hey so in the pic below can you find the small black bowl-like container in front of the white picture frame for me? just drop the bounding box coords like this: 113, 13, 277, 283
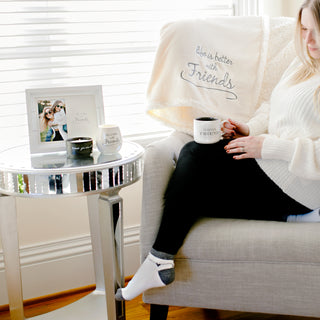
66, 137, 93, 159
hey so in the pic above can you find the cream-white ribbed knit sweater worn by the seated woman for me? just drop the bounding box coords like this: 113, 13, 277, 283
248, 59, 320, 209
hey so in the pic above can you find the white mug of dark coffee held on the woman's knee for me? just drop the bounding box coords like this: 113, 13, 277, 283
193, 117, 223, 144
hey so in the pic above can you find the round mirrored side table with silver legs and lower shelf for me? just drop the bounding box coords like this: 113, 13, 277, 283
0, 141, 144, 320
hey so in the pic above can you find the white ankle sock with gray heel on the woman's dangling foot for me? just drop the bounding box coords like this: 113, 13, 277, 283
116, 253, 174, 300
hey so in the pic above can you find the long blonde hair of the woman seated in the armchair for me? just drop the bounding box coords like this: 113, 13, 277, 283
292, 0, 320, 111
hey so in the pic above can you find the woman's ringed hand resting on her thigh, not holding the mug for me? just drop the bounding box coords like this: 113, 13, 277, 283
225, 136, 264, 160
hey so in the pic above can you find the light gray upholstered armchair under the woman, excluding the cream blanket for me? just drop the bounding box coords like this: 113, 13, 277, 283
141, 132, 320, 319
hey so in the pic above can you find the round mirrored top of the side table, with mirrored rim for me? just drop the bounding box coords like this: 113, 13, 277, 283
0, 141, 144, 197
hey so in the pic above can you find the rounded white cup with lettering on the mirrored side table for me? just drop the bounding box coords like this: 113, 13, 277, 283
97, 124, 122, 154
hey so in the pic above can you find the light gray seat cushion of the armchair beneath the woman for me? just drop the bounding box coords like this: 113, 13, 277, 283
177, 218, 320, 264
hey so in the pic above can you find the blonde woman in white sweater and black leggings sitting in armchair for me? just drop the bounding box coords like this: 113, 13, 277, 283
116, 0, 320, 300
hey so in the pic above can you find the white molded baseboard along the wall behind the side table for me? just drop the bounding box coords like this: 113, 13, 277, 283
0, 226, 140, 305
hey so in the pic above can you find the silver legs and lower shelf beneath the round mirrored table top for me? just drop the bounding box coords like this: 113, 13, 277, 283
0, 189, 125, 320
